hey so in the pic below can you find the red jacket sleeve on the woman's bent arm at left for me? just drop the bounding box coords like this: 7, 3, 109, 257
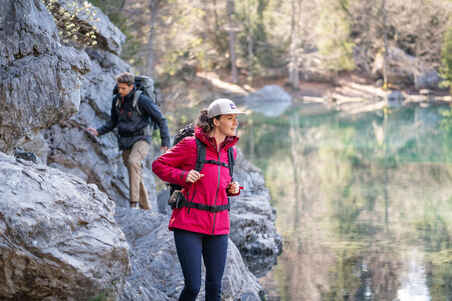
152, 139, 196, 185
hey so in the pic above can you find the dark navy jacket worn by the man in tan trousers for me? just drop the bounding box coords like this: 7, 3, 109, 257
97, 88, 170, 150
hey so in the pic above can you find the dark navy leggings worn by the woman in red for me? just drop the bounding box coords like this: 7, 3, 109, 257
174, 229, 228, 301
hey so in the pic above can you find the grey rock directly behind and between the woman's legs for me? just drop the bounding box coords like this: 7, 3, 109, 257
116, 208, 263, 301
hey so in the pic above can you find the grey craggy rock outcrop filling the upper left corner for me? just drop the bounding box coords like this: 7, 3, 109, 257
0, 0, 90, 151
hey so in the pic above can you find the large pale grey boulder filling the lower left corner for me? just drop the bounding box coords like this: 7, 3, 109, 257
0, 153, 129, 301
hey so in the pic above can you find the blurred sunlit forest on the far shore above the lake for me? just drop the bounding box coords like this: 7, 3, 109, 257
84, 0, 452, 89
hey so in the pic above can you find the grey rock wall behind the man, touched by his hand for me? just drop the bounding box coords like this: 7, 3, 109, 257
43, 49, 141, 206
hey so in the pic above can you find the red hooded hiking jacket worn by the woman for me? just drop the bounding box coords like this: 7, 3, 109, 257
152, 128, 239, 235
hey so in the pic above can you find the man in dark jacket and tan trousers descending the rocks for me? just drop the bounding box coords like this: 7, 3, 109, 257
86, 72, 170, 210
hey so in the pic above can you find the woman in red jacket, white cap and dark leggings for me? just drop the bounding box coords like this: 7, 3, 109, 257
152, 98, 243, 301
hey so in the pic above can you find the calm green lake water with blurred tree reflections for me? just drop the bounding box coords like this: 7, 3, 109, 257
241, 105, 452, 301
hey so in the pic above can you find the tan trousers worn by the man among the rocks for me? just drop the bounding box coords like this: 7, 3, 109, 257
122, 140, 151, 210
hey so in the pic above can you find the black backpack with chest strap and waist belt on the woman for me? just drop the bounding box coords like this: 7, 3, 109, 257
168, 123, 235, 212
